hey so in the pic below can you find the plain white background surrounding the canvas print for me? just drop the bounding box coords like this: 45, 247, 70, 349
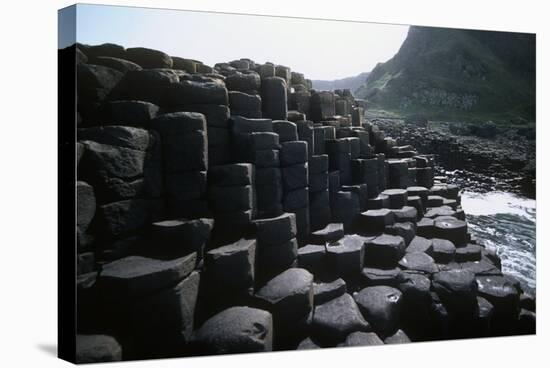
0, 0, 550, 368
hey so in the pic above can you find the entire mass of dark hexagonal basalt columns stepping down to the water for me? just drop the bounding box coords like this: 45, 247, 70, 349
69, 44, 536, 362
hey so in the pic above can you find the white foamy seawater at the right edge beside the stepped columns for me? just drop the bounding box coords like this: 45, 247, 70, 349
462, 191, 536, 293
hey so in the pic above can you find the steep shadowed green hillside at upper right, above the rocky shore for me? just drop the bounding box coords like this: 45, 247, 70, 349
356, 26, 535, 123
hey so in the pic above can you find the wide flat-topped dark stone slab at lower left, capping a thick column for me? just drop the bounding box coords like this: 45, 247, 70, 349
98, 253, 197, 298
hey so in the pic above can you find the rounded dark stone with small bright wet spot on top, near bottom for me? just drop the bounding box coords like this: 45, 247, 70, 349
353, 286, 402, 336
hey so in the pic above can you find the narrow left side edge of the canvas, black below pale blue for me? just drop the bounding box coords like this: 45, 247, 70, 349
57, 6, 76, 363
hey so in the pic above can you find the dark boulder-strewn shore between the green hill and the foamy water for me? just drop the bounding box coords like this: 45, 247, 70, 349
372, 118, 536, 198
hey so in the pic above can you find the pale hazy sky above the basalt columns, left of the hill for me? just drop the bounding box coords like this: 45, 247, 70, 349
69, 5, 409, 79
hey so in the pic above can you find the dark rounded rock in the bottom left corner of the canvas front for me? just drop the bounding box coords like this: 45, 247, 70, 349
75, 335, 122, 364
